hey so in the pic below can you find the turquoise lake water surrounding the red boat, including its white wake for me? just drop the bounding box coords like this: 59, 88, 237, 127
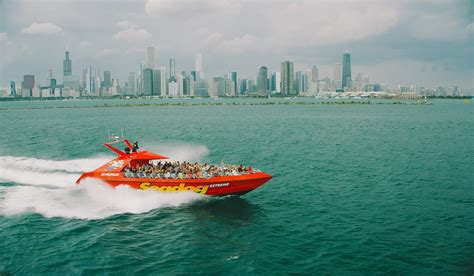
0, 99, 474, 275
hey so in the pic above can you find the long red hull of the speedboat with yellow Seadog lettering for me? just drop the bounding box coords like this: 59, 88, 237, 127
77, 172, 272, 196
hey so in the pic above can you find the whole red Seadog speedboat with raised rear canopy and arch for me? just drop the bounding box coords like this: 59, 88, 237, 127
76, 139, 272, 196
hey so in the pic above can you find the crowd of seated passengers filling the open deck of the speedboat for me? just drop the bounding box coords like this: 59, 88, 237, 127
124, 161, 255, 179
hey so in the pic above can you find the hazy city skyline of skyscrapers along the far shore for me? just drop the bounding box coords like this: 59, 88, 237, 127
0, 46, 472, 98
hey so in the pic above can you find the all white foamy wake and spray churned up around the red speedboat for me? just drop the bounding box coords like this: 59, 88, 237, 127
0, 145, 207, 219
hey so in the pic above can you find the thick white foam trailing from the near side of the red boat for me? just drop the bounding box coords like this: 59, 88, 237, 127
0, 180, 203, 219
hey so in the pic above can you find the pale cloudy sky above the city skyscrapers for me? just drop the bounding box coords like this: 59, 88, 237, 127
0, 0, 474, 88
